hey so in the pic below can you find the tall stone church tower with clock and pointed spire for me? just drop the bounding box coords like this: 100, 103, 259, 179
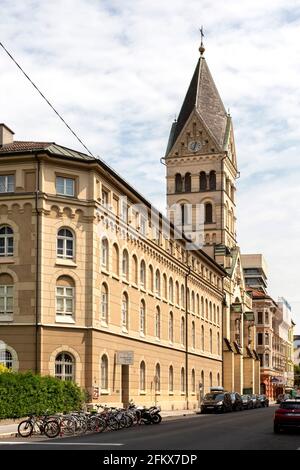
165, 39, 238, 268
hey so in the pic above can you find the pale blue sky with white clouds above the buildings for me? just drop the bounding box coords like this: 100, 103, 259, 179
0, 0, 300, 333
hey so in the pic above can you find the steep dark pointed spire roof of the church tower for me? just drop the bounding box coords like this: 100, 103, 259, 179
167, 57, 228, 153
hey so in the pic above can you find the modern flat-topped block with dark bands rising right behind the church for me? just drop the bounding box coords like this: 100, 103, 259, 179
242, 254, 268, 294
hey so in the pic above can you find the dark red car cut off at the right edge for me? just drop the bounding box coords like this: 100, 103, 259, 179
274, 398, 300, 434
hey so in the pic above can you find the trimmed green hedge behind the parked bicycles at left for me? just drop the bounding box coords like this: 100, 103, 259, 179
0, 372, 84, 419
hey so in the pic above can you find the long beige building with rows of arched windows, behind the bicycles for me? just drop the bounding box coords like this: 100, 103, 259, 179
0, 120, 226, 409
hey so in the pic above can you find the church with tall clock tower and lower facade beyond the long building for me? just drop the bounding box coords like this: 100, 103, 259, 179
165, 47, 260, 393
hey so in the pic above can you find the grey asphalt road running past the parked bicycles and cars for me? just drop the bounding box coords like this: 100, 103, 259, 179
0, 407, 300, 452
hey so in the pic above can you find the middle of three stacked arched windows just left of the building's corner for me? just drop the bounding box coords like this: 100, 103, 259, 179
56, 276, 75, 316
